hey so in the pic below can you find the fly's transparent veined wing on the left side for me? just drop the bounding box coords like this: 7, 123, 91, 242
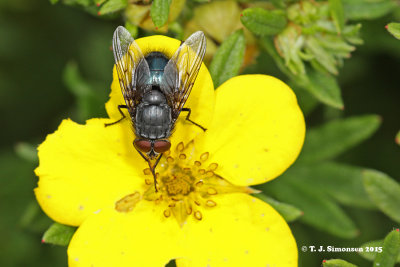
113, 26, 151, 114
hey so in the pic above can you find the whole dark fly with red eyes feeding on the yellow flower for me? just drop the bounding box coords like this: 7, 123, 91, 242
105, 26, 206, 192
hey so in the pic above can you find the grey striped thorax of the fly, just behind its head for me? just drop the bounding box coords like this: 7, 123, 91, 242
135, 103, 172, 139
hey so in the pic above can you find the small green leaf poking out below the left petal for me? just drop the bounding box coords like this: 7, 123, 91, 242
42, 223, 76, 246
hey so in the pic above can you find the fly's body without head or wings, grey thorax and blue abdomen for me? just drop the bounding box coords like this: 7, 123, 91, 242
135, 52, 173, 140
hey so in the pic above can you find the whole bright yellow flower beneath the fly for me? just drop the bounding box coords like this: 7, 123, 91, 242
35, 36, 305, 267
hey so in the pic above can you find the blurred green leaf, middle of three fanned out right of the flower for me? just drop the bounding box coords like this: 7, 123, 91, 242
285, 162, 376, 209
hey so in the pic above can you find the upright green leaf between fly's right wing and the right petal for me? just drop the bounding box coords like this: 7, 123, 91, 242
209, 30, 246, 88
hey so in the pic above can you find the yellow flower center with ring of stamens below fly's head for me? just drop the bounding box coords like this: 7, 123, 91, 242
138, 141, 254, 226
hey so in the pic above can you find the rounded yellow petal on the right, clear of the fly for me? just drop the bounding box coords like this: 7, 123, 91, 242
197, 75, 305, 185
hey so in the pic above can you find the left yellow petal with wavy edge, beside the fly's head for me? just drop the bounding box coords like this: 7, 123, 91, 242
35, 119, 148, 225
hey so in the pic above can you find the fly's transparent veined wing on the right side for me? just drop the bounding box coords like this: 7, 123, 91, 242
160, 31, 206, 121
